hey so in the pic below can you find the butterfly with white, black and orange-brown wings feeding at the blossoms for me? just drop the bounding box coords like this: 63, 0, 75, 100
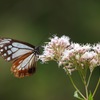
0, 38, 39, 78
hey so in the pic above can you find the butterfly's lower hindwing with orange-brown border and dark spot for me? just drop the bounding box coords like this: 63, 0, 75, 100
11, 53, 36, 78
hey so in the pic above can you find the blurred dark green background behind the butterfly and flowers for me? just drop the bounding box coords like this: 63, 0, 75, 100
0, 0, 100, 100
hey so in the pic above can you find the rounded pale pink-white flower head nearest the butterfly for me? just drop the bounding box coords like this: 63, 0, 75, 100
39, 36, 70, 62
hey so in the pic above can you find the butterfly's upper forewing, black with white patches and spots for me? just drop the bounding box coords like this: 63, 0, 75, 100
0, 38, 35, 61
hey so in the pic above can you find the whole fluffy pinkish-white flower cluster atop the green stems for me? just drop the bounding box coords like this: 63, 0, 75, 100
39, 36, 100, 73
